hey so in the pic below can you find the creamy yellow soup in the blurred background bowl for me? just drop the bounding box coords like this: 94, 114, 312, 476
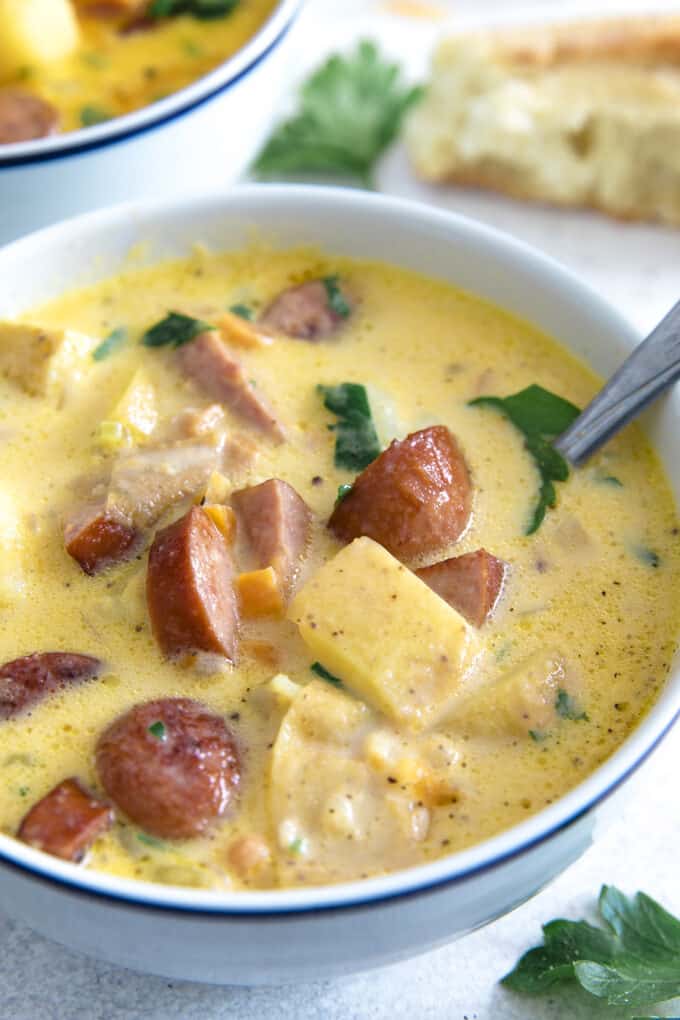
0, 0, 275, 132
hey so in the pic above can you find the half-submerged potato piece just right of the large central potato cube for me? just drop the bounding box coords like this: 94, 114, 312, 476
452, 651, 566, 736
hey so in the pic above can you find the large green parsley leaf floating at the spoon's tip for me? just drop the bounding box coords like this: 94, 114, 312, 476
470, 386, 581, 534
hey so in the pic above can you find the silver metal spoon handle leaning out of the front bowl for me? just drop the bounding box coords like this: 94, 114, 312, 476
553, 301, 680, 464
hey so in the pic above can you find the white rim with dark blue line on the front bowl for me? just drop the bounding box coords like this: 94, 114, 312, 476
0, 185, 680, 920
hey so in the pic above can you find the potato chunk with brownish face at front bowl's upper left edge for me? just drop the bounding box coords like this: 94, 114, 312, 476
0, 322, 97, 398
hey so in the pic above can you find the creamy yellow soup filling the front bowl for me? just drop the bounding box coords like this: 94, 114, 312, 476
0, 247, 680, 888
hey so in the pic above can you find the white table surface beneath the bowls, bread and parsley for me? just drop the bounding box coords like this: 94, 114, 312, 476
0, 0, 680, 1020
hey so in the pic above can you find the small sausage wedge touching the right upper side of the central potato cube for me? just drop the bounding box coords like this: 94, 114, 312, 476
416, 549, 508, 627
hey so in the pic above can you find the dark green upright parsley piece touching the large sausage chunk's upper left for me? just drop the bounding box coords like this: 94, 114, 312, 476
318, 383, 380, 471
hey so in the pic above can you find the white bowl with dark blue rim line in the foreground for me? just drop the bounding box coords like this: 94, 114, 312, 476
0, 187, 680, 984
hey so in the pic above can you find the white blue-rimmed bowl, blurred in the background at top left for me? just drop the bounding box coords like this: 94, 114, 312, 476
0, 0, 302, 244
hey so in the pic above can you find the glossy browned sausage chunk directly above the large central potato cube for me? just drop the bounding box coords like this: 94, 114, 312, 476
328, 425, 472, 562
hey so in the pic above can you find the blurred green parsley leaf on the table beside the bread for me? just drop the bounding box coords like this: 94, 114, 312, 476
253, 40, 422, 188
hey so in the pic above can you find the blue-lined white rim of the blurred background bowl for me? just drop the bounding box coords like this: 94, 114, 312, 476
0, 0, 304, 171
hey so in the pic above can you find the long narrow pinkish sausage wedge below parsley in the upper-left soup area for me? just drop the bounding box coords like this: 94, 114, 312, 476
178, 329, 283, 443
